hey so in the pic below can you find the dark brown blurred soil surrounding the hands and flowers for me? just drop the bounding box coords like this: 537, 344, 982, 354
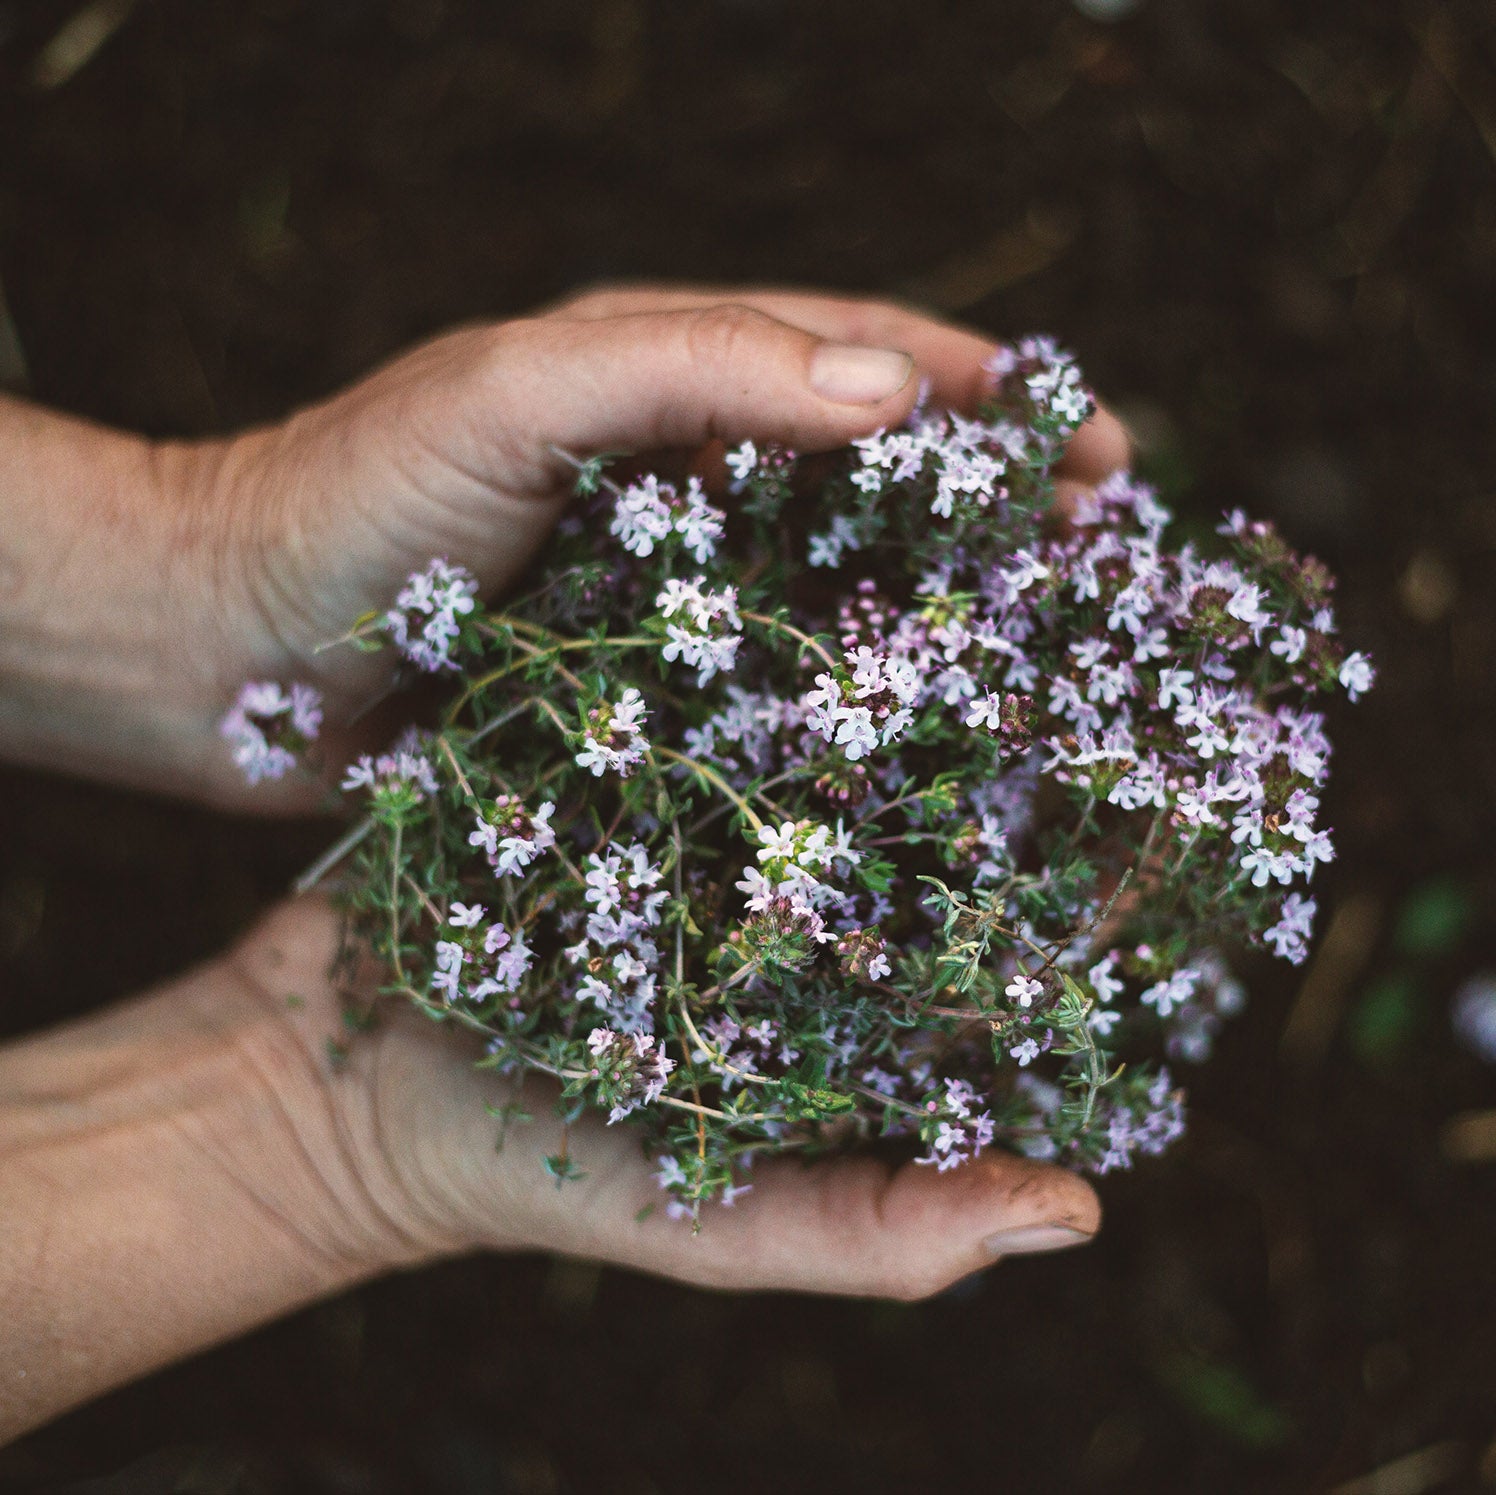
0, 0, 1496, 1495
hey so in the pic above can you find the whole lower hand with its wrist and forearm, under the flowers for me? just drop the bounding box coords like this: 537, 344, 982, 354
0, 898, 1100, 1444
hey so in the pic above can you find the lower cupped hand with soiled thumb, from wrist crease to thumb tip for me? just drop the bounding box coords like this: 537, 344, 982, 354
229, 898, 1101, 1299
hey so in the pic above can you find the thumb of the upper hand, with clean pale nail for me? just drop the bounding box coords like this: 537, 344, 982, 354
480, 304, 917, 481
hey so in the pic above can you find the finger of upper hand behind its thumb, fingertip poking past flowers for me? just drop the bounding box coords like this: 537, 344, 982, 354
548, 286, 1131, 483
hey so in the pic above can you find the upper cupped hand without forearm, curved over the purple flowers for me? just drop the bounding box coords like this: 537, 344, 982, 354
166, 287, 1128, 810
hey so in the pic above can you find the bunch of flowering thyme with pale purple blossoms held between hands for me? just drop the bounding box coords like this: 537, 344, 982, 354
227, 338, 1373, 1215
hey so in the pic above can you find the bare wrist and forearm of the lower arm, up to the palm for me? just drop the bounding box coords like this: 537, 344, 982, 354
0, 897, 459, 1441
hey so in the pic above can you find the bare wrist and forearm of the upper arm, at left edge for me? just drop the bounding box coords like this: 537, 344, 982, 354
0, 400, 237, 787
